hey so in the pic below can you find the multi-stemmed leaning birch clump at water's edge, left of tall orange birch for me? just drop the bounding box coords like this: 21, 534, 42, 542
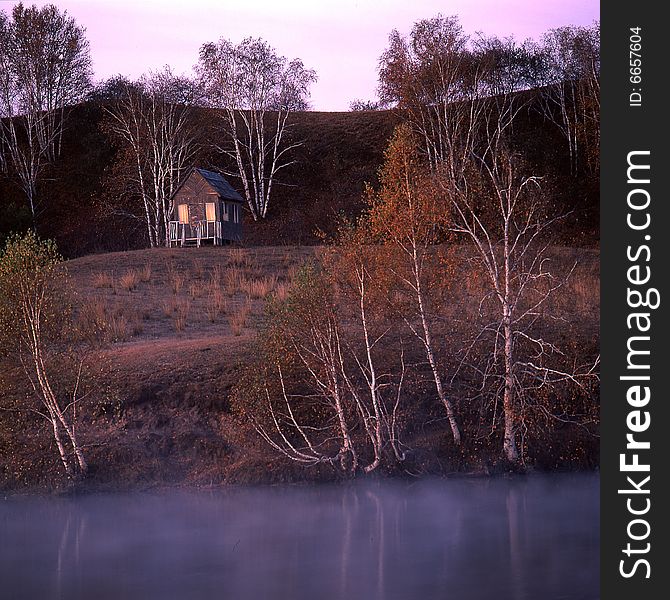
240, 266, 405, 475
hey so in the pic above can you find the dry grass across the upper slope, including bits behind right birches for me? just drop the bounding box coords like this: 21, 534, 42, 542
65, 247, 599, 376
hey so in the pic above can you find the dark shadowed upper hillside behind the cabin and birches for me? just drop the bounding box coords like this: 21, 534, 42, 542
0, 104, 599, 257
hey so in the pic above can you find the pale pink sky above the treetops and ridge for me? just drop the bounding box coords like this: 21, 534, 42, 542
0, 0, 600, 110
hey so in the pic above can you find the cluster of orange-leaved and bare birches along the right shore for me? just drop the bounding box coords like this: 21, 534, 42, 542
238, 116, 598, 475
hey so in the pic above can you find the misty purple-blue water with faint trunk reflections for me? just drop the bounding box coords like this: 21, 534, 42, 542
0, 474, 599, 600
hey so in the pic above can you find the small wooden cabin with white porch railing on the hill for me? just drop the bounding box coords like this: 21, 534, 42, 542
170, 168, 244, 246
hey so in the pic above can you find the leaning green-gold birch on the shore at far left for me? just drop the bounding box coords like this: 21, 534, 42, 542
0, 231, 88, 476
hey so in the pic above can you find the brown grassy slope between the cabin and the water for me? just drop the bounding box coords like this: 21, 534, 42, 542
0, 246, 599, 490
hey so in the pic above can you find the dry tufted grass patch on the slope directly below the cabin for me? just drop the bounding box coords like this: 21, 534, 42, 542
68, 247, 322, 352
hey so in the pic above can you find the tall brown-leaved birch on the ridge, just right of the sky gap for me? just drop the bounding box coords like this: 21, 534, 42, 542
379, 15, 545, 176
